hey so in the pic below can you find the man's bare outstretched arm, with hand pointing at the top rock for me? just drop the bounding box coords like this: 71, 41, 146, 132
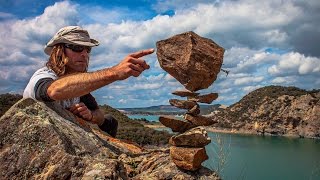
47, 49, 154, 100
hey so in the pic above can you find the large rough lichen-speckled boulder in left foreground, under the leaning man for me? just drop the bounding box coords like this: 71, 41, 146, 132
0, 99, 126, 179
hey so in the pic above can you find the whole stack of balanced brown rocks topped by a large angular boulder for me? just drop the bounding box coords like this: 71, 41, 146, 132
157, 32, 224, 171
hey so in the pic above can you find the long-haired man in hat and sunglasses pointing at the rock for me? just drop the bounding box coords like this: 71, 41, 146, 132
23, 26, 154, 137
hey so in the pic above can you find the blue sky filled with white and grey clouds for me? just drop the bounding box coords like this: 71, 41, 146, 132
0, 0, 320, 108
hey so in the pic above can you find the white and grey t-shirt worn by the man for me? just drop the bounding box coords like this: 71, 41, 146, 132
23, 67, 80, 108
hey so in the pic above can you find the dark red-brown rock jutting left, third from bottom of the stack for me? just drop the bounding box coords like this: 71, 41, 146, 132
159, 116, 195, 133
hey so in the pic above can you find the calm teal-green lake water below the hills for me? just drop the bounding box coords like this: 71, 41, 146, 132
127, 116, 320, 180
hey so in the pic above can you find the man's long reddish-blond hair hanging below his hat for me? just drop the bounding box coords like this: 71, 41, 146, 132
46, 44, 69, 77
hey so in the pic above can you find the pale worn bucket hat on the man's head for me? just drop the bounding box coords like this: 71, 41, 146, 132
44, 26, 99, 55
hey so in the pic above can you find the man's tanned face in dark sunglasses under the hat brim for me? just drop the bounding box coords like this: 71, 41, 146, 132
65, 44, 90, 74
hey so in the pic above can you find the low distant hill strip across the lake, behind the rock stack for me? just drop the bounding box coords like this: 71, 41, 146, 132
118, 104, 221, 115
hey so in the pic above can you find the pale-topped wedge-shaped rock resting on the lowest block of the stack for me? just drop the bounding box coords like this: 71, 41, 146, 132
169, 127, 211, 147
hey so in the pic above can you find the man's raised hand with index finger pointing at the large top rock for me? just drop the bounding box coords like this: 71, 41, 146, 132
111, 49, 154, 80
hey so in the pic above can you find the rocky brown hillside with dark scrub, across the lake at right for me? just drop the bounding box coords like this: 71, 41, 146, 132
213, 86, 320, 138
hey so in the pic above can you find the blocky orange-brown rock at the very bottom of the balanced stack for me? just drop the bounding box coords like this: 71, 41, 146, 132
170, 146, 208, 171
